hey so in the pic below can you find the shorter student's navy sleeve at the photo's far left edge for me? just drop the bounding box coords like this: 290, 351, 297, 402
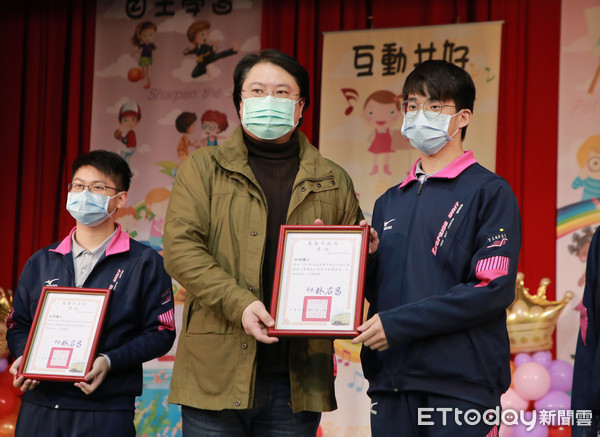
6, 260, 37, 358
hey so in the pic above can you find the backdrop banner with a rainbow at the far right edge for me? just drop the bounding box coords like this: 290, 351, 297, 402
556, 0, 600, 363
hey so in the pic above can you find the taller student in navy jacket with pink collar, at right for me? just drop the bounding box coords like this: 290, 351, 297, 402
353, 60, 521, 437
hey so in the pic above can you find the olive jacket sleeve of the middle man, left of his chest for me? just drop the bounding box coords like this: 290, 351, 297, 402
164, 150, 258, 324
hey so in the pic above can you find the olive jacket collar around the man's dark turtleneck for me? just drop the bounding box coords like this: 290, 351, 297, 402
214, 126, 333, 180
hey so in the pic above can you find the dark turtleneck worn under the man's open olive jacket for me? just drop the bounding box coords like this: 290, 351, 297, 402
244, 127, 300, 373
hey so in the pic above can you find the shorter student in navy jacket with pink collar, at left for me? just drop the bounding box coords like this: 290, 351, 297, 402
6, 150, 175, 437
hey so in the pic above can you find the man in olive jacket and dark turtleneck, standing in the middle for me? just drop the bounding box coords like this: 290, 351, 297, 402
164, 49, 376, 437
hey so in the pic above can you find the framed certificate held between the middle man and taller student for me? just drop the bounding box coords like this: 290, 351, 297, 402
268, 225, 369, 338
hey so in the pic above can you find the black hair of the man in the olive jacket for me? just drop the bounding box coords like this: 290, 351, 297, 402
233, 49, 310, 126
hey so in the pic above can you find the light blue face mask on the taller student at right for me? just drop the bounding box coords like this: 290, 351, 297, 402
401, 110, 461, 156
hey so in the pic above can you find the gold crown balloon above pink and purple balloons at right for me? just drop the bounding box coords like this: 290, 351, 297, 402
506, 272, 573, 354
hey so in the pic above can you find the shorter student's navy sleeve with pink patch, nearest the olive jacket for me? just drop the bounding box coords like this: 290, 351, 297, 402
105, 250, 175, 371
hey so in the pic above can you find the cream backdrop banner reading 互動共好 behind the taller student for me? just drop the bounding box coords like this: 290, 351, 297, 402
319, 22, 502, 436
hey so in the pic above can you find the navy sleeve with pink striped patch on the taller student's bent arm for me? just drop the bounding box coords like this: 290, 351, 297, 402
379, 181, 521, 346
